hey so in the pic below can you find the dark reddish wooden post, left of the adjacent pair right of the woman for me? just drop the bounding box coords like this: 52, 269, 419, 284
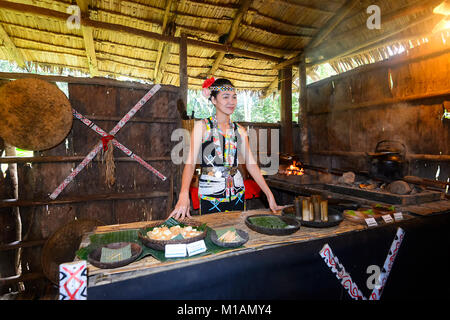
279, 66, 294, 153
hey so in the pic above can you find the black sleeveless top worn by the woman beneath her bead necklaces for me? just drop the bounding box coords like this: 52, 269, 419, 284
201, 118, 241, 167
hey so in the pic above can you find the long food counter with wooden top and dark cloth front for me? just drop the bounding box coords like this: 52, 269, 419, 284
77, 205, 450, 300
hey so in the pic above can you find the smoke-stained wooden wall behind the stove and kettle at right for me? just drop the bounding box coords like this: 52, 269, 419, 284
294, 39, 450, 181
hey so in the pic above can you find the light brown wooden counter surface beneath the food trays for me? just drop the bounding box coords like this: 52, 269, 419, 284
80, 210, 413, 287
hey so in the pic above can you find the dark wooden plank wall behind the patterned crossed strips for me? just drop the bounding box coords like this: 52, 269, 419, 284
6, 84, 180, 292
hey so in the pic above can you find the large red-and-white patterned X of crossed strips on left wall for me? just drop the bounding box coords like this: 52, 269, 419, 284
50, 84, 166, 200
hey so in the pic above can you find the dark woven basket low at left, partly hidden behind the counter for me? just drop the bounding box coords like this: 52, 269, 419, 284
41, 220, 104, 284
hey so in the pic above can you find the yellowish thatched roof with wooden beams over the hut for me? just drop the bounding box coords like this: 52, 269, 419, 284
0, 0, 442, 93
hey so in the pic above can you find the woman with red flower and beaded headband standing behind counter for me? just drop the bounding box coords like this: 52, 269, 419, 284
169, 78, 283, 219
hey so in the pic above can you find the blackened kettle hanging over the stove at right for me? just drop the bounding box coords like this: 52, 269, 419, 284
367, 140, 406, 181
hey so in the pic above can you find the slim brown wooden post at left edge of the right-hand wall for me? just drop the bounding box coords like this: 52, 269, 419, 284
298, 54, 309, 163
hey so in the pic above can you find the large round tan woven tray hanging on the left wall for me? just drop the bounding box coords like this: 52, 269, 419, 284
0, 78, 73, 151
